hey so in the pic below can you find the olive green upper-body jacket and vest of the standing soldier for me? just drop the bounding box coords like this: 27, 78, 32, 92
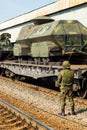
58, 69, 74, 86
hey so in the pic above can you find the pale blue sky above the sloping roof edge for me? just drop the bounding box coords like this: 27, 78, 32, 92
0, 0, 58, 23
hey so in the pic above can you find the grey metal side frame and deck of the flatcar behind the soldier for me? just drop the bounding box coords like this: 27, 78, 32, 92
0, 61, 87, 79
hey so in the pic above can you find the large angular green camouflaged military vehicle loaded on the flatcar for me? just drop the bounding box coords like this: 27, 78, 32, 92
13, 17, 87, 62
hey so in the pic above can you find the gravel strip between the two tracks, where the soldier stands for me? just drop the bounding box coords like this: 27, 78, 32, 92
0, 75, 87, 130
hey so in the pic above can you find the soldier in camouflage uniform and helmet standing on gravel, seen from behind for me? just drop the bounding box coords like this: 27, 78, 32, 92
56, 61, 75, 116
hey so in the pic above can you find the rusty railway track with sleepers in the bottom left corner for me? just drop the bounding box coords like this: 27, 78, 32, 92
0, 98, 53, 130
